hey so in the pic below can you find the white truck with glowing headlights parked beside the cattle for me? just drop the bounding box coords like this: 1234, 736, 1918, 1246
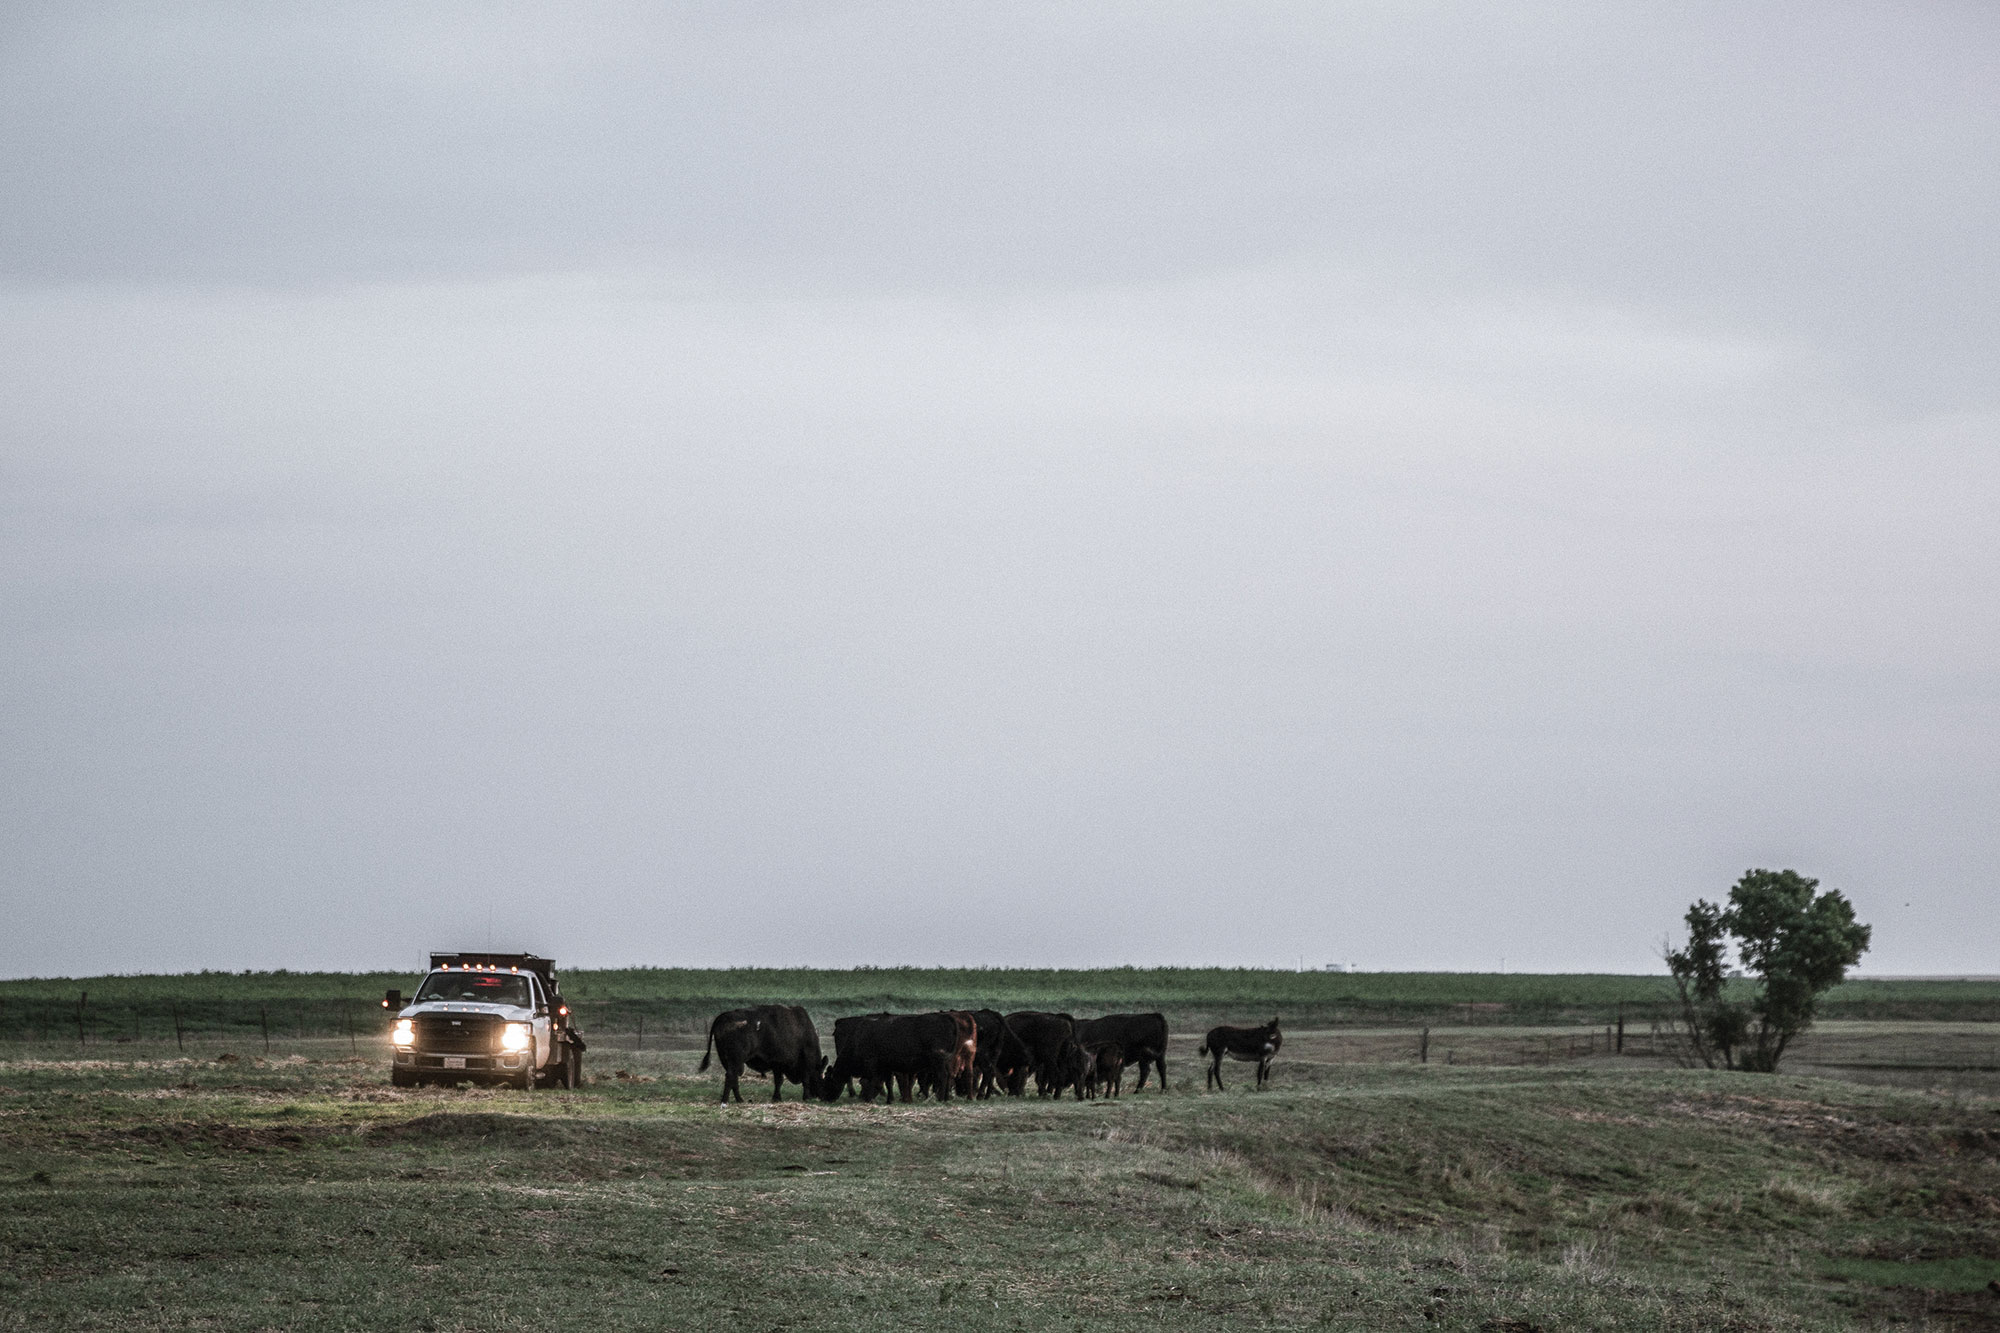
382, 953, 584, 1089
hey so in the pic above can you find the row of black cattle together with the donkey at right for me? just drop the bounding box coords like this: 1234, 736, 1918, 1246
700, 1005, 1284, 1103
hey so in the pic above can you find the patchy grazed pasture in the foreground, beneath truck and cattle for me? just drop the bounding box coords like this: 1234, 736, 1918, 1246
0, 1025, 2000, 1333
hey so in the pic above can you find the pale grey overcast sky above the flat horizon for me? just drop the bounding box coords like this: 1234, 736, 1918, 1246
0, 0, 2000, 975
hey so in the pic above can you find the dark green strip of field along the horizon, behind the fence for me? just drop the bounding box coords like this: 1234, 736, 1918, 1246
11, 967, 2000, 1045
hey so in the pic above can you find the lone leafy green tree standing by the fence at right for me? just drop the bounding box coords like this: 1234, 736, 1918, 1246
1666, 871, 1870, 1073
